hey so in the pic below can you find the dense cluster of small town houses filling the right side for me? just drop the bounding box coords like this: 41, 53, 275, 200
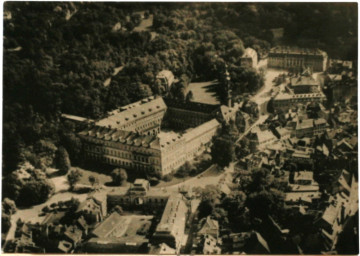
235, 50, 358, 254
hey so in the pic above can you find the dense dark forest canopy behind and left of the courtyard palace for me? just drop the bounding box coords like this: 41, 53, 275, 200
2, 2, 357, 210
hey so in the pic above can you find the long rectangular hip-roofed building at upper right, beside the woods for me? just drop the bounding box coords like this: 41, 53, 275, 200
268, 46, 328, 72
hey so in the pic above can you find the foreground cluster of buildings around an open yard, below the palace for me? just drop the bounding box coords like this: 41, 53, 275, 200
7, 178, 264, 254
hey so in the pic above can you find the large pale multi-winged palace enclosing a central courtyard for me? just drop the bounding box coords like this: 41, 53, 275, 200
78, 97, 220, 175
